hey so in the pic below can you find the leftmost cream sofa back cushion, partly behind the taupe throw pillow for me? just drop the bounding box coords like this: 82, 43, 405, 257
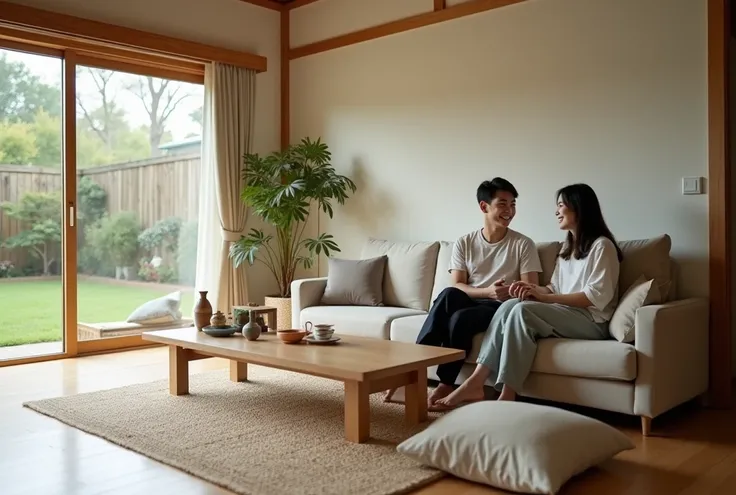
361, 239, 439, 311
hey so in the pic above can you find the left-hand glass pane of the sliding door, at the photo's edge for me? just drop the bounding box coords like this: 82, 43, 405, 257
0, 48, 63, 360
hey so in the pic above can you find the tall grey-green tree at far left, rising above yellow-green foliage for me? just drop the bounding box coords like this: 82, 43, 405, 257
0, 52, 61, 123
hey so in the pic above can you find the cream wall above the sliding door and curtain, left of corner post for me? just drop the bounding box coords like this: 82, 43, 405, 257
5, 0, 280, 301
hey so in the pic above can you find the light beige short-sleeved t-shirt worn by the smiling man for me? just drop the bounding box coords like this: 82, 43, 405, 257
450, 229, 542, 288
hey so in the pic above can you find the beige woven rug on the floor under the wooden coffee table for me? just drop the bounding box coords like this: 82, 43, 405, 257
24, 366, 443, 495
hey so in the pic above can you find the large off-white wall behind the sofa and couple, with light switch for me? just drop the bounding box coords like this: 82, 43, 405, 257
291, 0, 708, 296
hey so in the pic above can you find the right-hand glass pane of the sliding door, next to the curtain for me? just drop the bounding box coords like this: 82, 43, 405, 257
77, 66, 204, 341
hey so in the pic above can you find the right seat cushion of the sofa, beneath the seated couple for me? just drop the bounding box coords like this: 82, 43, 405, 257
390, 315, 636, 381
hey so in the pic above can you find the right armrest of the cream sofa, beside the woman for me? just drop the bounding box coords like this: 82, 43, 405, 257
634, 298, 709, 418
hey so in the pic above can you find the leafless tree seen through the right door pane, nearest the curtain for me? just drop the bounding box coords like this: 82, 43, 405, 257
128, 76, 190, 156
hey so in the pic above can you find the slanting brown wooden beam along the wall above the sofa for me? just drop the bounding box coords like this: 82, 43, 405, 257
289, 0, 526, 60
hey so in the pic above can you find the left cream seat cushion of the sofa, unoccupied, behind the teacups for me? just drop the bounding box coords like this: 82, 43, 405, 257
299, 306, 425, 339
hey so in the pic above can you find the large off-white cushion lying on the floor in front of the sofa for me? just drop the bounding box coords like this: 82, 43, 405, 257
397, 401, 634, 494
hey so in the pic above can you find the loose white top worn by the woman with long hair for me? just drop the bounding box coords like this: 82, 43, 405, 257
548, 237, 620, 323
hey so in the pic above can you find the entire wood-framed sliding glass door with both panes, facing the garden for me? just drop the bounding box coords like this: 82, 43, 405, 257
0, 39, 204, 366
